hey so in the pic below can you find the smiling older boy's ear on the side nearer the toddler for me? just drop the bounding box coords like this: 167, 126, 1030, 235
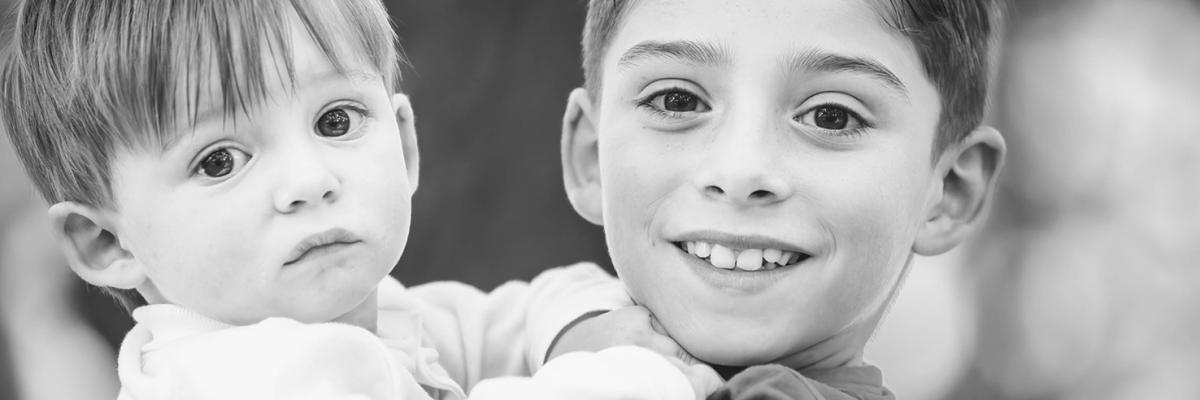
563, 88, 604, 225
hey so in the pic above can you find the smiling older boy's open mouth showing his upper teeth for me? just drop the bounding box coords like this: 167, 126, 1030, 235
671, 241, 811, 271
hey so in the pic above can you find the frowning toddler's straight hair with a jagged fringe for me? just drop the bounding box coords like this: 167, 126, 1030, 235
0, 0, 402, 310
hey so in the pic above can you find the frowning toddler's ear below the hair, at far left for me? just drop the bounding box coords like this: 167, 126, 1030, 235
47, 202, 146, 289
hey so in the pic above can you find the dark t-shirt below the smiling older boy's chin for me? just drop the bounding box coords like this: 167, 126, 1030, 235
708, 364, 895, 400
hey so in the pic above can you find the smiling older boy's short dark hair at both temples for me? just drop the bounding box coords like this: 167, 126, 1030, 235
583, 0, 1003, 155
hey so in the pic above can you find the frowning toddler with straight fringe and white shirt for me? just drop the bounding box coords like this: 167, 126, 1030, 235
2, 0, 673, 399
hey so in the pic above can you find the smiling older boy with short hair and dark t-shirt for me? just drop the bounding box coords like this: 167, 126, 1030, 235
563, 0, 1004, 399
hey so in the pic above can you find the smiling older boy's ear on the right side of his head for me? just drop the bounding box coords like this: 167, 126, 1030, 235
912, 126, 1007, 256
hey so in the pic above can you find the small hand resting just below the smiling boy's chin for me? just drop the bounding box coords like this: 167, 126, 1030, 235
546, 305, 696, 360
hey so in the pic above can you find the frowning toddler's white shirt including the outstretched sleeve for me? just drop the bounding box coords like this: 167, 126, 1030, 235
118, 263, 630, 400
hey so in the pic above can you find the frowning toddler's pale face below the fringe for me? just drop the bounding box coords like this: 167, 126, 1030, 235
113, 23, 415, 323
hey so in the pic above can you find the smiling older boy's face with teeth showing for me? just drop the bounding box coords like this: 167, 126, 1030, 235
577, 0, 941, 365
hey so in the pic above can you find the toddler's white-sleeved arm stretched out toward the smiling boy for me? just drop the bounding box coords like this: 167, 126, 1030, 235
398, 263, 631, 389
